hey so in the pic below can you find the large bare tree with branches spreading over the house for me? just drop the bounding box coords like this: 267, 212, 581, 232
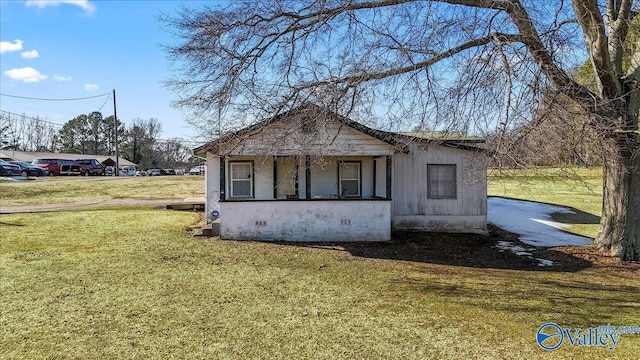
161, 0, 640, 260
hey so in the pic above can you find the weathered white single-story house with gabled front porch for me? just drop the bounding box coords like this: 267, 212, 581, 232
194, 105, 487, 242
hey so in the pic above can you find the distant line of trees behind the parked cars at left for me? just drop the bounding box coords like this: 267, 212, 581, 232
0, 111, 198, 169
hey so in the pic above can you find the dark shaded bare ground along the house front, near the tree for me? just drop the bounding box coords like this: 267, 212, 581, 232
260, 225, 592, 272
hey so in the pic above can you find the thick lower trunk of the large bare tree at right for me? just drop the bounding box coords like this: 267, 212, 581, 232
594, 132, 640, 261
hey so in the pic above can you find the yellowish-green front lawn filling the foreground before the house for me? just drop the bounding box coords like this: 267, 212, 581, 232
0, 171, 640, 359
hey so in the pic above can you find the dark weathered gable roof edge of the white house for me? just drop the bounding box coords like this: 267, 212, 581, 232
193, 103, 484, 157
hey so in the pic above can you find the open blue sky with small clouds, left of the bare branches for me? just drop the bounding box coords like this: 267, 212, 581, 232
0, 0, 210, 140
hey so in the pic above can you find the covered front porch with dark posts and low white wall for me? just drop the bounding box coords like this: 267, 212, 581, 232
206, 153, 392, 241
